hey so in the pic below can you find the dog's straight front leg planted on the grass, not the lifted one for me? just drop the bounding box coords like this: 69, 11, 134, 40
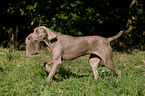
47, 57, 61, 82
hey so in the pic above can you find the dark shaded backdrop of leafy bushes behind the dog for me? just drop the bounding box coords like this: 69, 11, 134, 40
0, 0, 145, 50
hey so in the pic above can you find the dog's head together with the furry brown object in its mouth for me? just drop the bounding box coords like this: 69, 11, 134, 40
25, 26, 56, 57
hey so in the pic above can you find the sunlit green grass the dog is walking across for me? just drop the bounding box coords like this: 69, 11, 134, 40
0, 48, 145, 96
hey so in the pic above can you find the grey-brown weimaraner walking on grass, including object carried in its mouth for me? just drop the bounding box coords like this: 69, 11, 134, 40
26, 26, 123, 81
